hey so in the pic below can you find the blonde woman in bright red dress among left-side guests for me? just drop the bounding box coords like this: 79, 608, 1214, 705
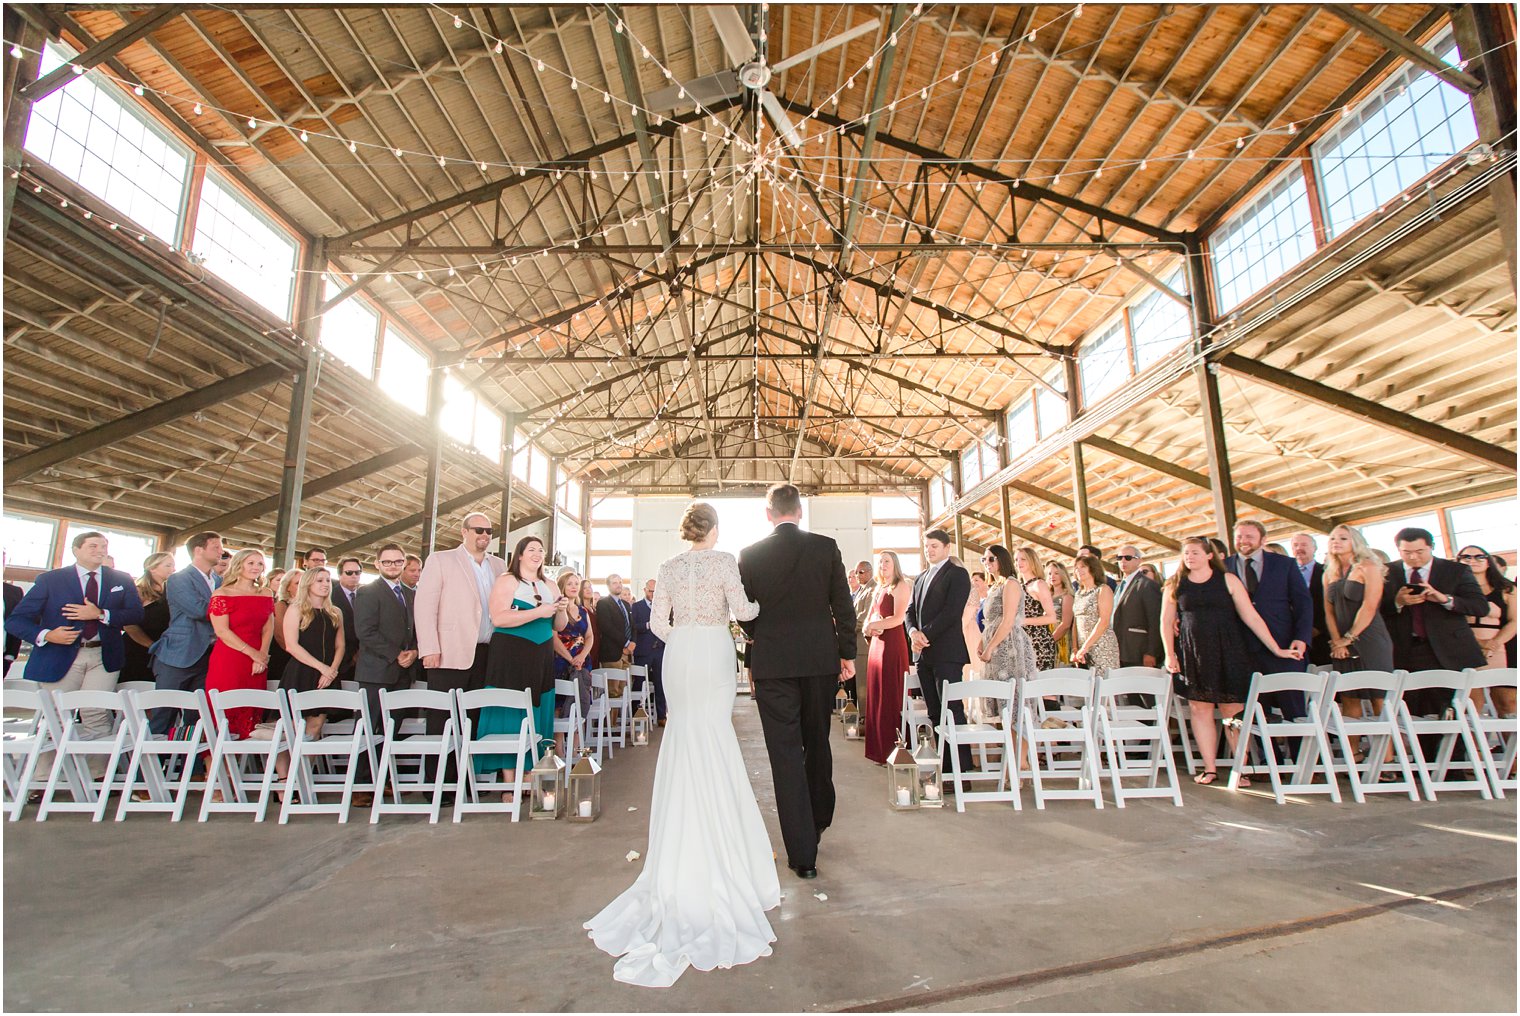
205, 551, 275, 739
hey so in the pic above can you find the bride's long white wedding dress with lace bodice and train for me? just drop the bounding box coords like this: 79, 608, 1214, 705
585, 551, 781, 987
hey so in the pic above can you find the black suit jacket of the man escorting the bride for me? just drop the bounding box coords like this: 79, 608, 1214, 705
739, 522, 856, 680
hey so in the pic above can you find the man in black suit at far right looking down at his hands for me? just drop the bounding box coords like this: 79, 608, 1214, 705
1383, 526, 1488, 716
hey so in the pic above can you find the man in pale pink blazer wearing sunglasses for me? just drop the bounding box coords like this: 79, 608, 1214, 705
415, 511, 506, 757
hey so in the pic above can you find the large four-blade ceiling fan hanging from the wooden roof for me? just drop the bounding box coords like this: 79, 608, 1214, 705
644, 5, 882, 148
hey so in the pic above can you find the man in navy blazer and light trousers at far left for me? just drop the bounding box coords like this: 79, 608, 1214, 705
5, 532, 143, 738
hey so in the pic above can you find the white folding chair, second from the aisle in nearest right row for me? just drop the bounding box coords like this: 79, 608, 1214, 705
1018, 666, 1104, 809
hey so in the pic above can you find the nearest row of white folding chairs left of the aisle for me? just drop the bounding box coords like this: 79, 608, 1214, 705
3, 681, 581, 823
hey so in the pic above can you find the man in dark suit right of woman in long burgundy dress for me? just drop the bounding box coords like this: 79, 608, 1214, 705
906, 529, 973, 773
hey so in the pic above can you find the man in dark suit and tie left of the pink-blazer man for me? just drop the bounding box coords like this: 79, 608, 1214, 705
348, 543, 416, 805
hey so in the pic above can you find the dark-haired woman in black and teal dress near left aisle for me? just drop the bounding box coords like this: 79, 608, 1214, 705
474, 537, 570, 802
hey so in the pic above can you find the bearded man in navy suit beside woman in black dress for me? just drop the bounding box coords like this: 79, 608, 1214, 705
1225, 519, 1315, 719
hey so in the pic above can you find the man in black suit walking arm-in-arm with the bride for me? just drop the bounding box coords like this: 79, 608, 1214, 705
739, 484, 856, 879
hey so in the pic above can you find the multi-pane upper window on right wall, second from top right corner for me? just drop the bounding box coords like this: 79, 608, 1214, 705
1208, 166, 1315, 310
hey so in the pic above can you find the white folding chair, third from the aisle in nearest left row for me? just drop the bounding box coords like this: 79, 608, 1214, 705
280, 684, 375, 826
